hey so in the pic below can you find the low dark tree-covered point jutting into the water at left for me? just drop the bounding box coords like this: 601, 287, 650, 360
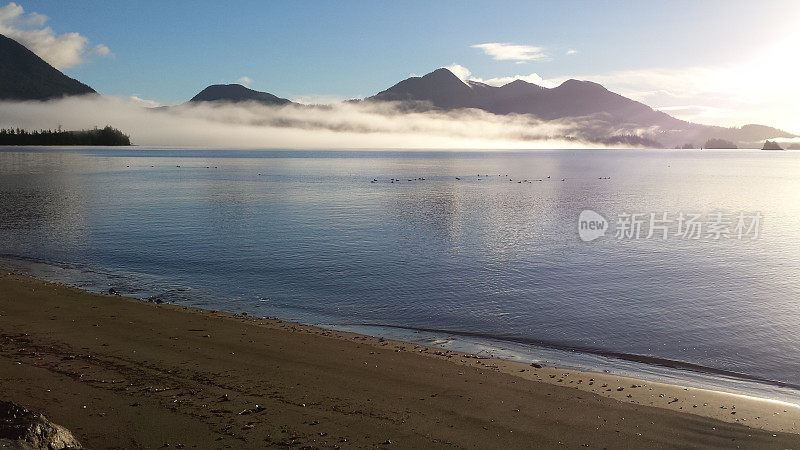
0, 126, 131, 146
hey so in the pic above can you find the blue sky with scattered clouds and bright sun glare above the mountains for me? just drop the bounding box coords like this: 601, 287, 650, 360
0, 0, 800, 133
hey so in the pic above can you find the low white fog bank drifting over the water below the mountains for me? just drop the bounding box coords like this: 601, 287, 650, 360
0, 96, 668, 149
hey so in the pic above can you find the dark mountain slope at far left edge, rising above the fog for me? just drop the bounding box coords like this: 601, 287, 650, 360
0, 34, 97, 100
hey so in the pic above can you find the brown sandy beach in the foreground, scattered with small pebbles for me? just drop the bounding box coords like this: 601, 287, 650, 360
0, 272, 800, 449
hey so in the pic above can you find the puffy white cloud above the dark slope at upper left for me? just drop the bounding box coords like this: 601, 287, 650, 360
0, 2, 111, 69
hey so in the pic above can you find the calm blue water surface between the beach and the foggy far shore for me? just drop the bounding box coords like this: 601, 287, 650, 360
0, 147, 800, 399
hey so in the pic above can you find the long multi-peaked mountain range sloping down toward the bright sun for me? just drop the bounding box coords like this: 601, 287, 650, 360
366, 68, 795, 148
